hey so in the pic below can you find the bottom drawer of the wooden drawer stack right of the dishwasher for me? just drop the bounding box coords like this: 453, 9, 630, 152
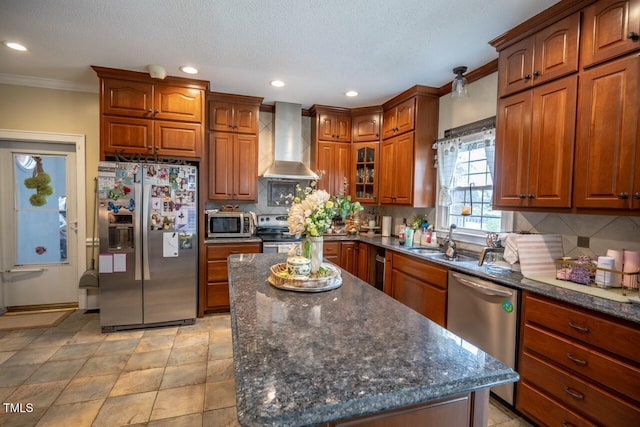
516, 381, 596, 427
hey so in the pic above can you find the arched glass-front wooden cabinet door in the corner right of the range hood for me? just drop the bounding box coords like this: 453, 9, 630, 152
351, 142, 380, 203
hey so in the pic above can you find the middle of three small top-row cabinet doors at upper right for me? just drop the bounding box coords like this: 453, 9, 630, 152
532, 12, 580, 85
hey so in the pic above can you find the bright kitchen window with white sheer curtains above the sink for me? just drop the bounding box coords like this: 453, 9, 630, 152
436, 130, 511, 241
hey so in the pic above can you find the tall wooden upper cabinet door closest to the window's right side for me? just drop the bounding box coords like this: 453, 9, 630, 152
493, 91, 532, 207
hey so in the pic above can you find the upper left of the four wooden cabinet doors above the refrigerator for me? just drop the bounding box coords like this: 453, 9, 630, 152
102, 79, 153, 117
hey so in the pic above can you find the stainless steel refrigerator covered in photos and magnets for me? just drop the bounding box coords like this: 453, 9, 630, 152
98, 162, 198, 332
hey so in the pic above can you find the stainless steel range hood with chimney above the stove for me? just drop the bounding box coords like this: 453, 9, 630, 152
262, 102, 318, 180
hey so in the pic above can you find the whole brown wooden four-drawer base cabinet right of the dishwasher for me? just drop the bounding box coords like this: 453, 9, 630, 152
516, 291, 640, 426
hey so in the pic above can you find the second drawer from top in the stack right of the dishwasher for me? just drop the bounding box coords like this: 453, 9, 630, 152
524, 325, 640, 402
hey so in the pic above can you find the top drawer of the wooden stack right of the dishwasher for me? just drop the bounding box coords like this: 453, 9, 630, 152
524, 292, 640, 363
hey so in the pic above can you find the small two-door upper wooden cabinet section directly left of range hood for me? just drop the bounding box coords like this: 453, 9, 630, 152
207, 93, 262, 134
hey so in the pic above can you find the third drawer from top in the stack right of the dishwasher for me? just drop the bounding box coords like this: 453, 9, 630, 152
519, 349, 640, 426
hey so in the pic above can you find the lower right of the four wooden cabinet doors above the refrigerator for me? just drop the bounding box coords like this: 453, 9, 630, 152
154, 120, 203, 159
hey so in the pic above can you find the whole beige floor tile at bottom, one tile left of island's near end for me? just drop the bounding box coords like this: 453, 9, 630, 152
150, 384, 204, 420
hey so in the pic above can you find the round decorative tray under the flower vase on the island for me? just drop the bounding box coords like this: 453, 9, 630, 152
267, 262, 342, 292
